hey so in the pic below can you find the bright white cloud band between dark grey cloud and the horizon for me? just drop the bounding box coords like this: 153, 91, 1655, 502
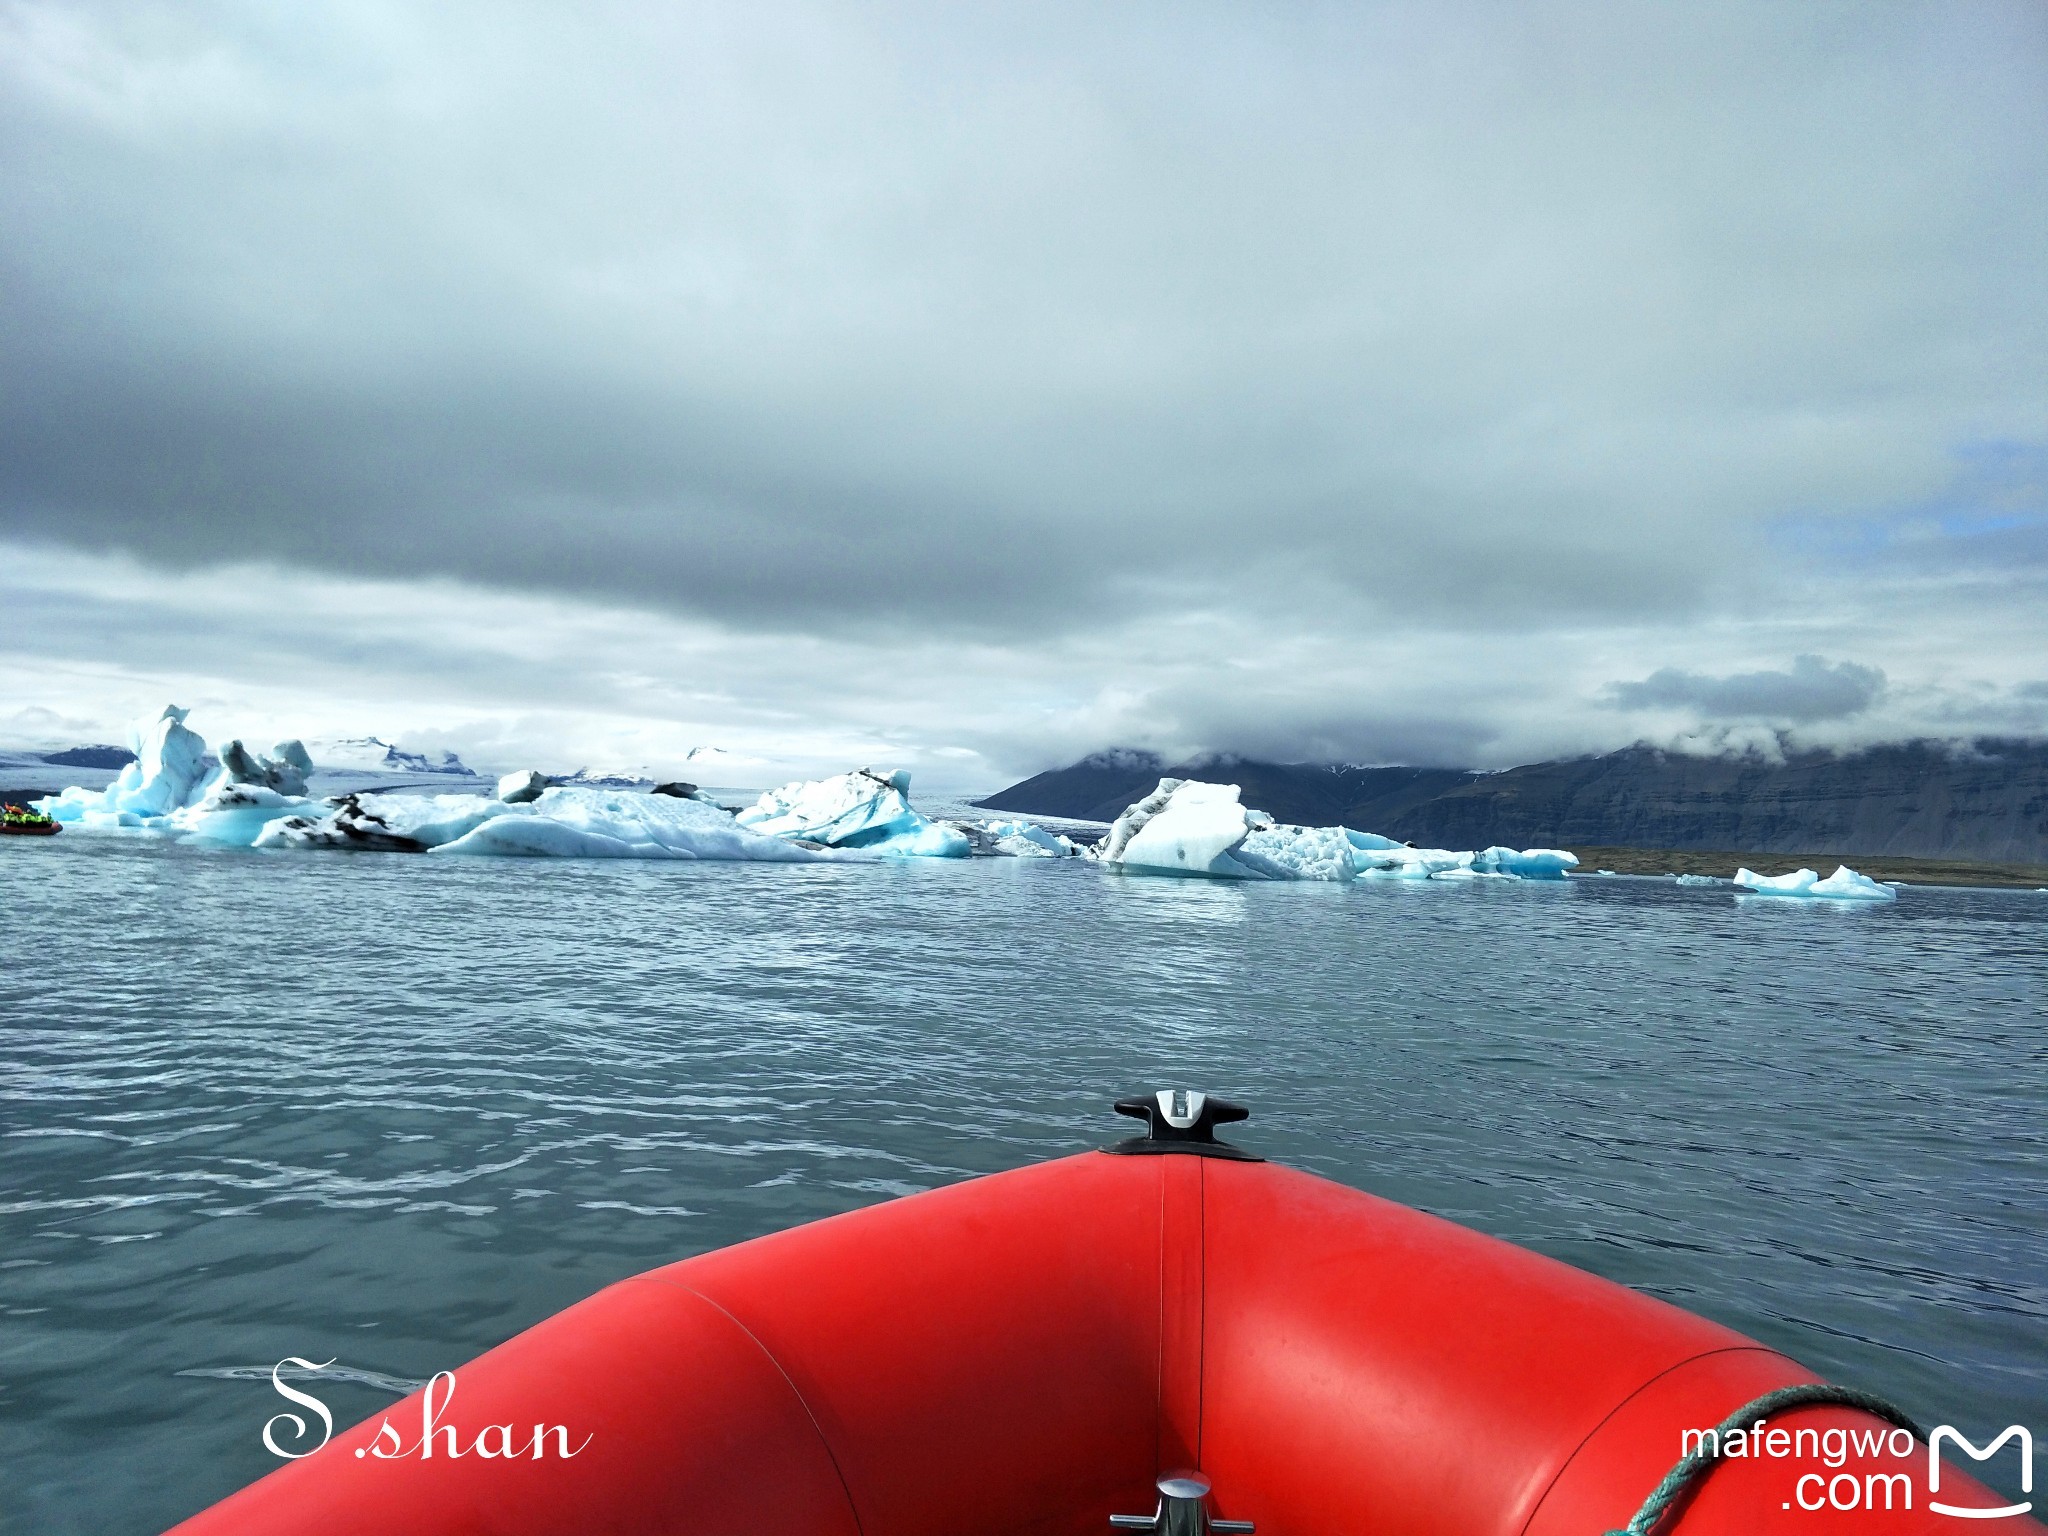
0, 545, 2048, 791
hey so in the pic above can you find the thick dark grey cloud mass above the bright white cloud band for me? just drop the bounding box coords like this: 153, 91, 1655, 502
0, 4, 2048, 638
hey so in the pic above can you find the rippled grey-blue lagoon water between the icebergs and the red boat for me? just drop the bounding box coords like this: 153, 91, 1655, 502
0, 836, 2048, 1532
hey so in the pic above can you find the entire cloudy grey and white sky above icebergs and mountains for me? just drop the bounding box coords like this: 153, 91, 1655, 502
0, 0, 2048, 786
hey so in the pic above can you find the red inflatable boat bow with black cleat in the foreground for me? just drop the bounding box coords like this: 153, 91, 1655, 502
178, 1094, 2042, 1536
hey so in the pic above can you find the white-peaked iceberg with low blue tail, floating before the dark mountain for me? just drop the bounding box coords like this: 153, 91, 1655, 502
1094, 778, 1579, 881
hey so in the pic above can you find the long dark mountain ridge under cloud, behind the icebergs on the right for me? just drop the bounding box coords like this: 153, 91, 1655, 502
979, 739, 2048, 864
